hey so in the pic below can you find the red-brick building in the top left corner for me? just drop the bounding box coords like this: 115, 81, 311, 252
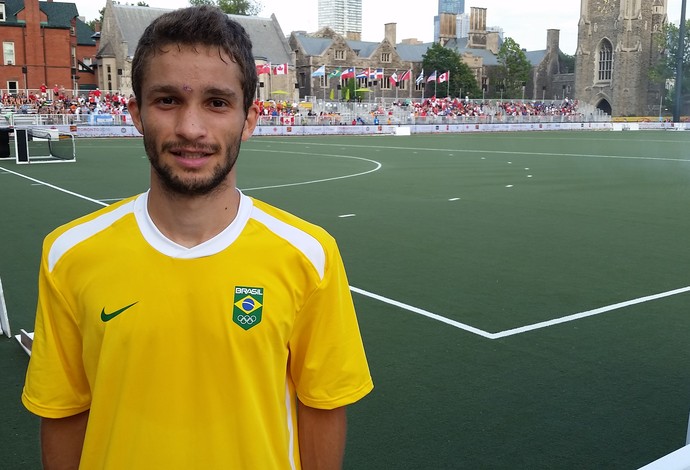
0, 0, 97, 94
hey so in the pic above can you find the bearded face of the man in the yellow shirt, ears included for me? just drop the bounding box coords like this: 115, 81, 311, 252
129, 45, 258, 196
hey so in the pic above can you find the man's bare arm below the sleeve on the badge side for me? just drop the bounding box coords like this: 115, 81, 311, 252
297, 401, 347, 470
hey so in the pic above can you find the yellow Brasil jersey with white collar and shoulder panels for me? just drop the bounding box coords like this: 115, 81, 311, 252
22, 189, 373, 470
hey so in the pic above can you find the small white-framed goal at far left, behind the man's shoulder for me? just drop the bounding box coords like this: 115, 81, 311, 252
14, 127, 77, 163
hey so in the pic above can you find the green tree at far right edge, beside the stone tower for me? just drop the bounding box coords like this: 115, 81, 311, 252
649, 20, 690, 115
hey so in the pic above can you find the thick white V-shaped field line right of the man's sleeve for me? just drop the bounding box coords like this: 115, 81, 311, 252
350, 286, 690, 340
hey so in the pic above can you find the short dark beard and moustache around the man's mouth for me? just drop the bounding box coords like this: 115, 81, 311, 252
144, 135, 242, 196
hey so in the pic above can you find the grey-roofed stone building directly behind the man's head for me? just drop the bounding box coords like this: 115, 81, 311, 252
98, 0, 297, 100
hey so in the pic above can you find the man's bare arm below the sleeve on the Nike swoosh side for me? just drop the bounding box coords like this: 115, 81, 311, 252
41, 411, 89, 470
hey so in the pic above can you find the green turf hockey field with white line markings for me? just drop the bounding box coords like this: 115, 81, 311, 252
0, 132, 690, 469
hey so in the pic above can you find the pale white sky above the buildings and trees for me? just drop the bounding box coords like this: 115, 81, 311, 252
73, 0, 690, 54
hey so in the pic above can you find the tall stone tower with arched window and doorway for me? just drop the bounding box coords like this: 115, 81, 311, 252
575, 0, 668, 116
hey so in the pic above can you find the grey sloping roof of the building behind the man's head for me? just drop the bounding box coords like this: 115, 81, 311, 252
105, 3, 291, 64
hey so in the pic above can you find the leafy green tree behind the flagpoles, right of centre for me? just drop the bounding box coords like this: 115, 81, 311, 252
422, 43, 481, 98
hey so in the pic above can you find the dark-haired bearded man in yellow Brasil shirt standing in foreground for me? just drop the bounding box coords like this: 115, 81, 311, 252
22, 7, 373, 470
